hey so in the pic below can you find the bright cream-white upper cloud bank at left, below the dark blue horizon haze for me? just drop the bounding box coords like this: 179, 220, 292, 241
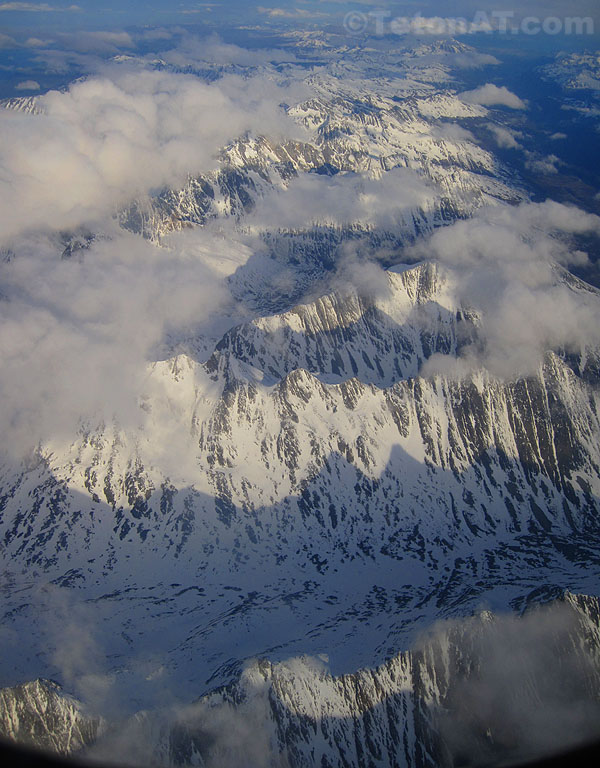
0, 69, 298, 243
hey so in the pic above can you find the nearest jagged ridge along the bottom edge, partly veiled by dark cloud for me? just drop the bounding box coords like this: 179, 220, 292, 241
0, 594, 600, 768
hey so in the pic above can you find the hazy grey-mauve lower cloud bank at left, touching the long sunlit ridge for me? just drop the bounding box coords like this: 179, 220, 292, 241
0, 226, 244, 456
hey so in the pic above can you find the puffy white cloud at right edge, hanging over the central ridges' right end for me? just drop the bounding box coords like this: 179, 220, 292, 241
416, 202, 600, 378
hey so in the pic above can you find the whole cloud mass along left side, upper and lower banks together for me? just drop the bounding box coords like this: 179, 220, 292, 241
0, 68, 298, 454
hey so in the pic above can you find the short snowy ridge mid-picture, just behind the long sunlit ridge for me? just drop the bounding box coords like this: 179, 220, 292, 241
207, 263, 472, 388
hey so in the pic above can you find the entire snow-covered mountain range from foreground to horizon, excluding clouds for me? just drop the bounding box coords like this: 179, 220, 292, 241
0, 31, 600, 766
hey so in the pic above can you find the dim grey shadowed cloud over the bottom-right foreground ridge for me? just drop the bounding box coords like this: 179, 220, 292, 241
420, 603, 600, 765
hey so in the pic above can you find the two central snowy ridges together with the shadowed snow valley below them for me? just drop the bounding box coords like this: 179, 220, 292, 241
2, 264, 600, 704
